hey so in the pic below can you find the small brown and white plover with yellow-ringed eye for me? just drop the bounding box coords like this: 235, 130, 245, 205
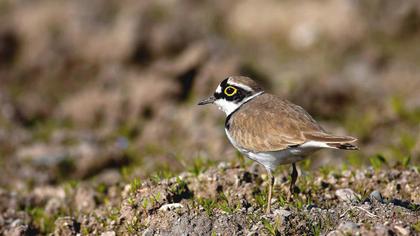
198, 76, 358, 214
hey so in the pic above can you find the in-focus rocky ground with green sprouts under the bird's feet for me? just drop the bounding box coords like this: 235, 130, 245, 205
0, 162, 420, 235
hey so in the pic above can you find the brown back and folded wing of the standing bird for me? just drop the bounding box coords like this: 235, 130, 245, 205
228, 93, 344, 152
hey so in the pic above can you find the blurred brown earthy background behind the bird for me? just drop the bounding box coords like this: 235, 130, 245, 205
0, 0, 420, 190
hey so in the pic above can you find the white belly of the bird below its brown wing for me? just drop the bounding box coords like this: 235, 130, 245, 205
225, 129, 322, 171
